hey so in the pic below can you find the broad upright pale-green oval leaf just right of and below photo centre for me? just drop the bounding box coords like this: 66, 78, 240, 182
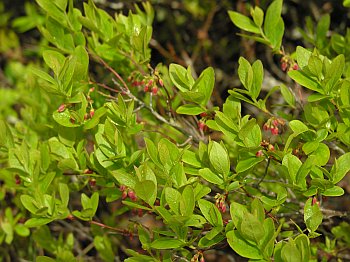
209, 141, 230, 175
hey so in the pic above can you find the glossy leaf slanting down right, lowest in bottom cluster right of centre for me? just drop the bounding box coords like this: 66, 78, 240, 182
226, 230, 263, 259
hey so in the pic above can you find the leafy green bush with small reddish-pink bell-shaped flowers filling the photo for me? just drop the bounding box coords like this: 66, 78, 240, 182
0, 0, 350, 261
